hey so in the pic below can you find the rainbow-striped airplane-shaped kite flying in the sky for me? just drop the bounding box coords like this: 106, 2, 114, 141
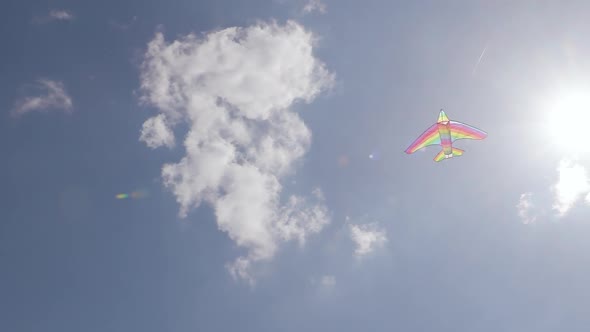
406, 109, 488, 161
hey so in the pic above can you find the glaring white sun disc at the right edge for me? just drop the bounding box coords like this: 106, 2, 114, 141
546, 90, 590, 154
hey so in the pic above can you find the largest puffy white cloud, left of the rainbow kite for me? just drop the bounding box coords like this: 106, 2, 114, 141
141, 22, 333, 282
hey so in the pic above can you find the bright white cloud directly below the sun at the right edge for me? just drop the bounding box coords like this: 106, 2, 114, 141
553, 160, 590, 216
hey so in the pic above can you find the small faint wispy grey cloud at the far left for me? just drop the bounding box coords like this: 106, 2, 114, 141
12, 79, 73, 116
